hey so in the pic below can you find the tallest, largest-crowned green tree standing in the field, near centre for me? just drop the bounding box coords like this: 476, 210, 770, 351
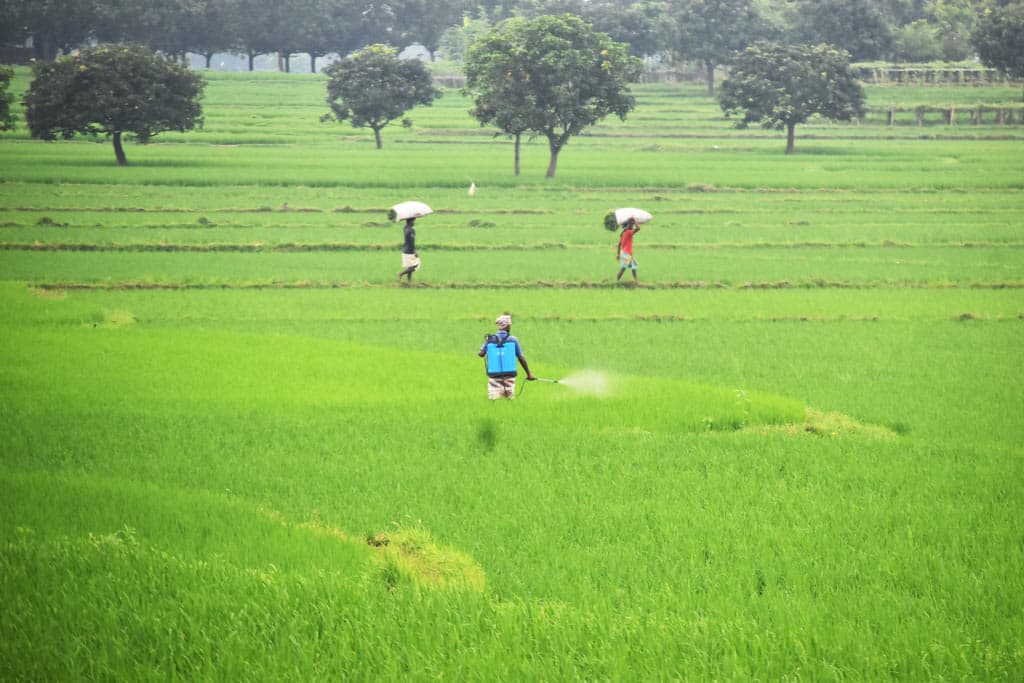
466, 14, 642, 178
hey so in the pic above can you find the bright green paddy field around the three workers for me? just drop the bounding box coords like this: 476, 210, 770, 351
0, 71, 1024, 681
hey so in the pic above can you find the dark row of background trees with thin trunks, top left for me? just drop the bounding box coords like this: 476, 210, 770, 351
0, 0, 467, 71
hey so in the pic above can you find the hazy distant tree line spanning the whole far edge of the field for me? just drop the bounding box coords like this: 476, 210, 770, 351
0, 0, 1022, 80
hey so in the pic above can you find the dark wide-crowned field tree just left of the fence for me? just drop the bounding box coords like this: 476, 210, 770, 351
719, 42, 864, 155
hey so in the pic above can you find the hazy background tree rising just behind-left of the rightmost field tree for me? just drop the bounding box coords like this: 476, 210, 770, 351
671, 0, 767, 95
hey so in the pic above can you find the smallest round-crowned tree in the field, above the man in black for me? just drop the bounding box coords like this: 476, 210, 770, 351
324, 44, 441, 150
